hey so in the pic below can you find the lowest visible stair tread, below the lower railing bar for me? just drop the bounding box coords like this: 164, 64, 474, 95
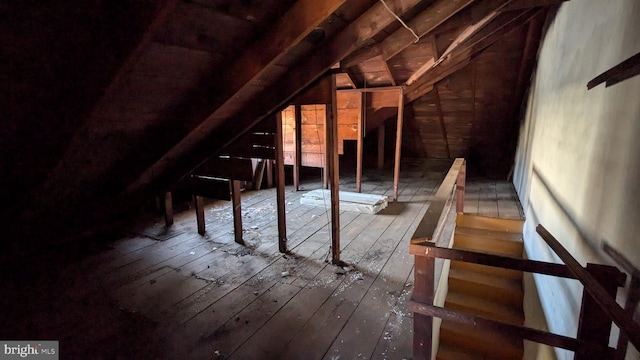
440, 320, 524, 359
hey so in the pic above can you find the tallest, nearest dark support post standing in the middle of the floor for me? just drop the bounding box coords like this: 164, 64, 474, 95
325, 75, 340, 264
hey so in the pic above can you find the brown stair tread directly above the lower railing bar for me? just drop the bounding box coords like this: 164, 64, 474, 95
445, 291, 524, 326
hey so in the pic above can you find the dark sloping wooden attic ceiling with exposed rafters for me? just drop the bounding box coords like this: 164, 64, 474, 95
0, 0, 562, 250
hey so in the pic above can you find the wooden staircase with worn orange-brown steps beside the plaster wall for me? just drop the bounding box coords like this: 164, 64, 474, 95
437, 214, 524, 360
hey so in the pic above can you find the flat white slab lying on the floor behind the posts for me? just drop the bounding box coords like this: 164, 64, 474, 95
300, 189, 389, 214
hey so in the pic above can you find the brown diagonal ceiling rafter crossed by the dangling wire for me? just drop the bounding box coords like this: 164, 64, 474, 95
344, 0, 474, 67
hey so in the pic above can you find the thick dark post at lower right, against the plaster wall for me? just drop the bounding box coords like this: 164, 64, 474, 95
575, 264, 619, 360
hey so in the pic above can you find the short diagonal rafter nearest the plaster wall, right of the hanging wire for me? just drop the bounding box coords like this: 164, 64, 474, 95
405, 9, 542, 103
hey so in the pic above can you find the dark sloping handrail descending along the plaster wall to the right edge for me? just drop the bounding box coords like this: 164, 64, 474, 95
536, 225, 640, 349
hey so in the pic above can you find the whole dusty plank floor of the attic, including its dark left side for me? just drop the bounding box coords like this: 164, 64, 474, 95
0, 162, 520, 359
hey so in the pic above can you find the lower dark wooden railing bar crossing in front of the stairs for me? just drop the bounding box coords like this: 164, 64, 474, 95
409, 300, 615, 359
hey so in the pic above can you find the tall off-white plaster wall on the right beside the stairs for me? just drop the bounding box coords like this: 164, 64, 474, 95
514, 0, 640, 359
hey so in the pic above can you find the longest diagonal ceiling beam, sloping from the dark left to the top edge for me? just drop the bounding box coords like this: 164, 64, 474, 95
120, 0, 428, 201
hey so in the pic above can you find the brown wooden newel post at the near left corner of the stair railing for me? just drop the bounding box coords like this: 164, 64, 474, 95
412, 255, 435, 360
